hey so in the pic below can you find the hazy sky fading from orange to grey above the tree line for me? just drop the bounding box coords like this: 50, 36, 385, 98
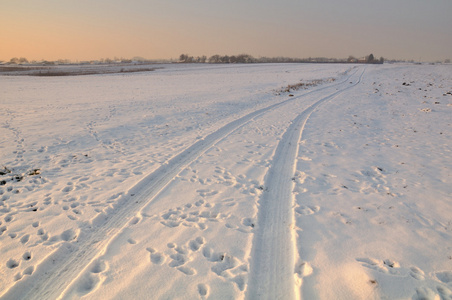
0, 0, 452, 61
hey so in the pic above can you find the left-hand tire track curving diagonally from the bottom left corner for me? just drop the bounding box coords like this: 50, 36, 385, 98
0, 71, 357, 299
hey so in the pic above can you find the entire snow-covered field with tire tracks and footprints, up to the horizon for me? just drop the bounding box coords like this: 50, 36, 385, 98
0, 64, 452, 300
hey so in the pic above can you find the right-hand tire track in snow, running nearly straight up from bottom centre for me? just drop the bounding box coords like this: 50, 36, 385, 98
247, 70, 365, 300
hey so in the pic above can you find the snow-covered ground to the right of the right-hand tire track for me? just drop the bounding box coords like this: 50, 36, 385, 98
295, 66, 452, 299
